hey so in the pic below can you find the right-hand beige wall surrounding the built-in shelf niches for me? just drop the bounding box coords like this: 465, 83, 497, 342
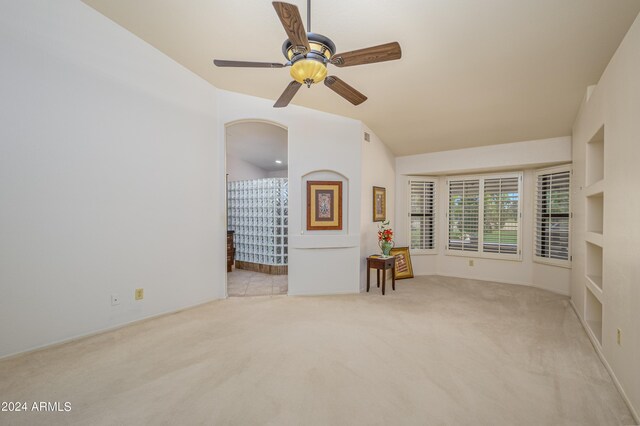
571, 11, 640, 421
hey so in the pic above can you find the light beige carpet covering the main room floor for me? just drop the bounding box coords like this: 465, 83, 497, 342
0, 277, 633, 425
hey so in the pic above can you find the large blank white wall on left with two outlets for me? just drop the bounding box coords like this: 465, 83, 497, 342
0, 0, 225, 357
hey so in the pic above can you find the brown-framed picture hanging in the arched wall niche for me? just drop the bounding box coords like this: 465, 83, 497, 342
307, 181, 342, 231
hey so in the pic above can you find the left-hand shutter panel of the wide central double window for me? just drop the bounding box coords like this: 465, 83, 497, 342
448, 179, 480, 252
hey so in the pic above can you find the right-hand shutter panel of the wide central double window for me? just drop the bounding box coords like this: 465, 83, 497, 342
482, 176, 520, 254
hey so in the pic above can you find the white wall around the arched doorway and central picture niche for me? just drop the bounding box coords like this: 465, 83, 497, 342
217, 90, 362, 295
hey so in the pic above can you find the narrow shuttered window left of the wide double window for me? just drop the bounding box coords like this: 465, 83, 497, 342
409, 178, 436, 250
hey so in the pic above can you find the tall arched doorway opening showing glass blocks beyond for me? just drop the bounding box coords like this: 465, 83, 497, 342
225, 120, 289, 297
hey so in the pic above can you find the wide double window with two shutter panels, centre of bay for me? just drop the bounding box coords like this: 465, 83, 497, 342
447, 173, 522, 259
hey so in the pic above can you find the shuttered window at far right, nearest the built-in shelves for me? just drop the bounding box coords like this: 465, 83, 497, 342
534, 166, 571, 264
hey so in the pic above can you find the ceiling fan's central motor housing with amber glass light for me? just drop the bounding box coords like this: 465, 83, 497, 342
282, 33, 336, 87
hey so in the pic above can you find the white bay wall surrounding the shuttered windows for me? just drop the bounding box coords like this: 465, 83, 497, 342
396, 137, 571, 295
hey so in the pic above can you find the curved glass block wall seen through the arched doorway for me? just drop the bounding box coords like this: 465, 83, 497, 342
228, 178, 289, 265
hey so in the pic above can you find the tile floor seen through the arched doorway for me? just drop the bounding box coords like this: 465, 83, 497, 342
227, 268, 289, 297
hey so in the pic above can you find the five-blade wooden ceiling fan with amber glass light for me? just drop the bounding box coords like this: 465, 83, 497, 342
218, 0, 402, 108
